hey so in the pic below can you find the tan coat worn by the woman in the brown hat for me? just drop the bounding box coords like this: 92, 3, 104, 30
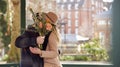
41, 32, 61, 67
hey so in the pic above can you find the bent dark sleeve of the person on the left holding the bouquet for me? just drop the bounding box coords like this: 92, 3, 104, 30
15, 31, 37, 48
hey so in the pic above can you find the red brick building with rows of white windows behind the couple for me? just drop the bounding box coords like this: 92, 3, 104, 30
57, 0, 93, 43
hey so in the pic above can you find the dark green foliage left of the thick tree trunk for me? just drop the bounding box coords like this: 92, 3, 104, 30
0, 0, 11, 49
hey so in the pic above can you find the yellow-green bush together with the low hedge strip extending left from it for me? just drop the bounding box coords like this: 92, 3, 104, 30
60, 39, 109, 61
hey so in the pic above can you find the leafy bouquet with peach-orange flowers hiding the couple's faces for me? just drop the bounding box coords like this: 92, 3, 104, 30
30, 8, 53, 49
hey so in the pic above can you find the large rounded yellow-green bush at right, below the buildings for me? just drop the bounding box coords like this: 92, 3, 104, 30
81, 39, 109, 61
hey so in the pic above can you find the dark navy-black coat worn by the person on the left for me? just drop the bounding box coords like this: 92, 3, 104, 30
15, 28, 44, 67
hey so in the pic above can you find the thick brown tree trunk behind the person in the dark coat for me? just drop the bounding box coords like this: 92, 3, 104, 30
8, 0, 20, 62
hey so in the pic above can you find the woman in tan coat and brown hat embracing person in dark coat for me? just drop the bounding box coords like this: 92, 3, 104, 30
30, 12, 61, 67
